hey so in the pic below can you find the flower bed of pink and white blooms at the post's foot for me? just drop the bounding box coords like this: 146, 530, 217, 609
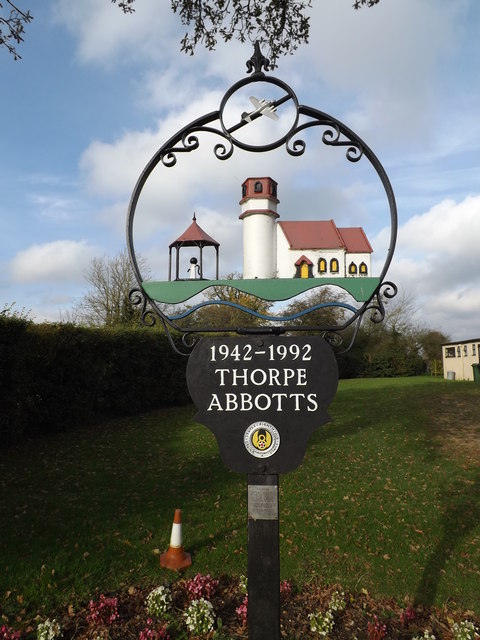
0, 574, 480, 640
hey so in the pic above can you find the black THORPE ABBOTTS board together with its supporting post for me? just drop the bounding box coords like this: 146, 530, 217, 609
187, 336, 338, 640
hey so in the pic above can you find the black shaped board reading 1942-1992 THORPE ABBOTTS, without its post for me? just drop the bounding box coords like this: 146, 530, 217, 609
187, 336, 338, 474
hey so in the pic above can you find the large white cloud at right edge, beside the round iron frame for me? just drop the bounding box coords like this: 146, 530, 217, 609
374, 196, 480, 339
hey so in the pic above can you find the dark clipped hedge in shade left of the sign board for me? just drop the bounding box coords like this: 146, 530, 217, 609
0, 317, 190, 444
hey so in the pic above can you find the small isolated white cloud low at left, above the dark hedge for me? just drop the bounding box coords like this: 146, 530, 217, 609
10, 240, 98, 283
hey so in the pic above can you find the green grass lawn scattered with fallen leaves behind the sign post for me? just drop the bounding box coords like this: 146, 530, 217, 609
0, 378, 480, 618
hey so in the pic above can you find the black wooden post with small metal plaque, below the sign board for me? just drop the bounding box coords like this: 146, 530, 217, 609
248, 474, 280, 640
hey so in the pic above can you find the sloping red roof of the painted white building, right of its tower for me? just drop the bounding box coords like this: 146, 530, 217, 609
278, 220, 373, 253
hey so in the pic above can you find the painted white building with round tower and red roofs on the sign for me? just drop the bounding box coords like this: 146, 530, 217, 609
240, 177, 373, 279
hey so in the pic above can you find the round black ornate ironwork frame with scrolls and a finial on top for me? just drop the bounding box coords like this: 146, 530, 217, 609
127, 43, 398, 355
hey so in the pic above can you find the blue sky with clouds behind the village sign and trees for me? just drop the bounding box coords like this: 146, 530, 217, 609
0, 0, 480, 339
